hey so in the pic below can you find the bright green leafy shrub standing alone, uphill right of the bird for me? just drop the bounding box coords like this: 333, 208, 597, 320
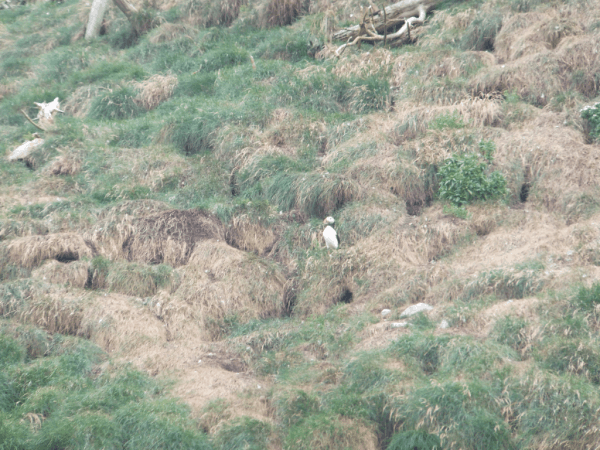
437, 154, 507, 206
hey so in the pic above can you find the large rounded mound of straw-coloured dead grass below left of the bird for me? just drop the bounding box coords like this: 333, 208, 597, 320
157, 239, 287, 339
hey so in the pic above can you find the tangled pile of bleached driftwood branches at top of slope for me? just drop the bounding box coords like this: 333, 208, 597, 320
333, 0, 441, 56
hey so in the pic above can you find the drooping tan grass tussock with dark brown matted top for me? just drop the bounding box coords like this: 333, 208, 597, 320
123, 210, 225, 267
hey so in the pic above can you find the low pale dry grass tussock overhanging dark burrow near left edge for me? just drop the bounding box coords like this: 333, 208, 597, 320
7, 233, 95, 268
